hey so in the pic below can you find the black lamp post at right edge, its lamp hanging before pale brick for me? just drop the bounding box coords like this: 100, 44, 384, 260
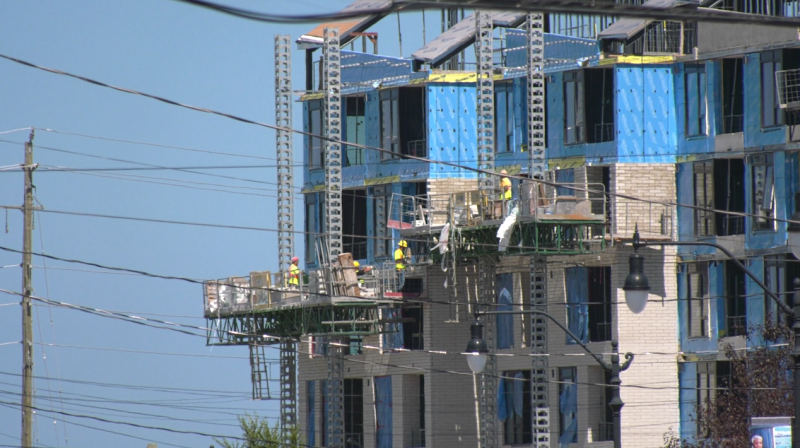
622, 229, 800, 447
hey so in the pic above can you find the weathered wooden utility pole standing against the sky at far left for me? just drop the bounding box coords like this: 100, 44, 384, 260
20, 131, 36, 448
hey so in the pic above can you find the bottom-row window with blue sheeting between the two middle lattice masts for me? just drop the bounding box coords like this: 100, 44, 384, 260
501, 370, 533, 445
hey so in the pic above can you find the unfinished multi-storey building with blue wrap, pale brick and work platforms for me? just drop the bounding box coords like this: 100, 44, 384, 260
198, 0, 800, 448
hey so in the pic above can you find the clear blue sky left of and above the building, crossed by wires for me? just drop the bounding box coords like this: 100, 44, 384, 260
0, 0, 439, 448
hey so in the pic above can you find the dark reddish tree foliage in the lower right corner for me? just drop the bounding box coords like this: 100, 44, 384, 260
664, 319, 794, 448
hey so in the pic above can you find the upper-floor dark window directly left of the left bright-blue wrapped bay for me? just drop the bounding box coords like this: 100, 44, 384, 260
379, 87, 427, 160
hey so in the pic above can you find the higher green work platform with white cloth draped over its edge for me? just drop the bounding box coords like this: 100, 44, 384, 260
390, 182, 608, 262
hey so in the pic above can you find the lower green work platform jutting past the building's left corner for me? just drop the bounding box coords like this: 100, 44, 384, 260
203, 262, 406, 345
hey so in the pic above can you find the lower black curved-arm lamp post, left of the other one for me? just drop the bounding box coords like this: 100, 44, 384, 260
464, 310, 636, 448
